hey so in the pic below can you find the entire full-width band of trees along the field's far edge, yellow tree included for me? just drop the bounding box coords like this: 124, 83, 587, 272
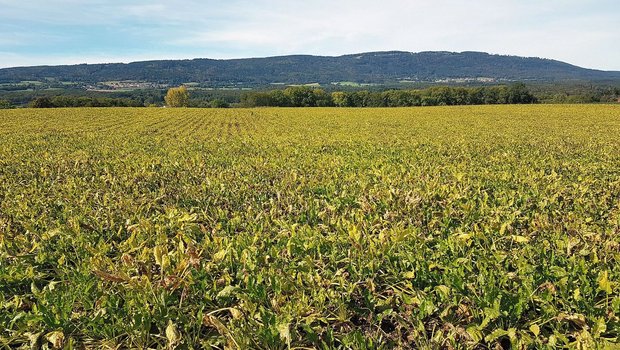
17, 83, 620, 109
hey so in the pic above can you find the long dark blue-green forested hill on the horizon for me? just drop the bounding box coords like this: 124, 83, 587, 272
0, 51, 620, 86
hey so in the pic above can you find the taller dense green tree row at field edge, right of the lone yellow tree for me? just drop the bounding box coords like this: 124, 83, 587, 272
241, 83, 538, 107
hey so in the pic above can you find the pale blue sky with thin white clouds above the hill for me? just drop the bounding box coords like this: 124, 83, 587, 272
0, 0, 620, 71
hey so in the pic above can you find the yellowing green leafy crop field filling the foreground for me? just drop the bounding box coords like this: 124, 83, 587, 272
0, 105, 620, 349
